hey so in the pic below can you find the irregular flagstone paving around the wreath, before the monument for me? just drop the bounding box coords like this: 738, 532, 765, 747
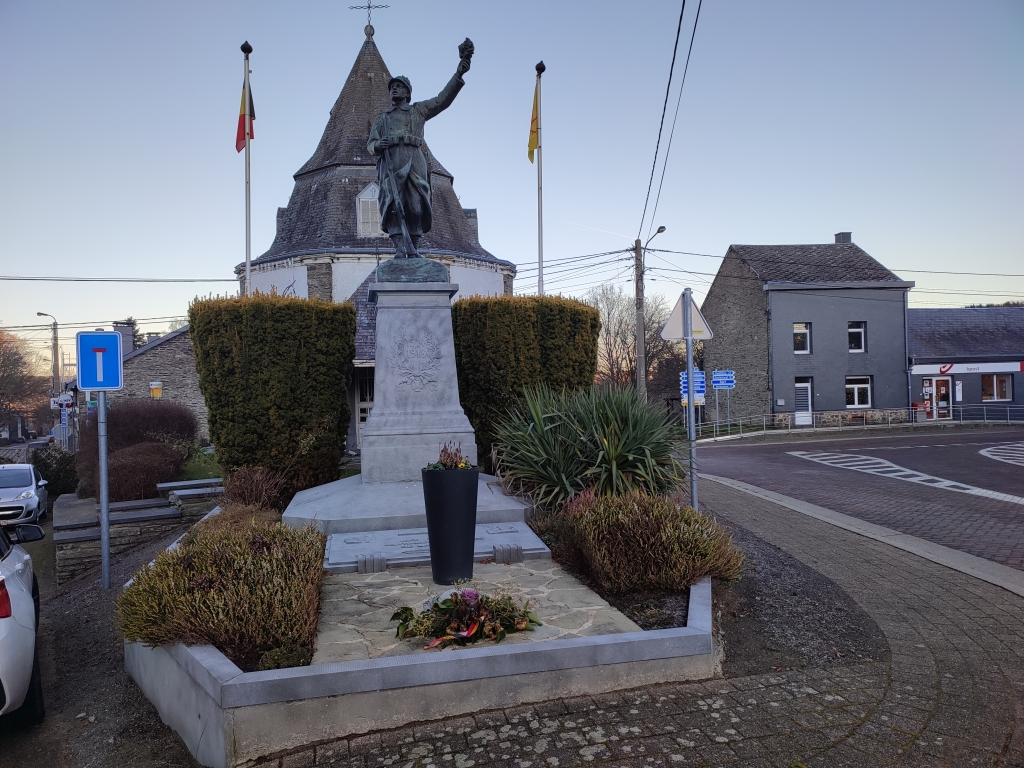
312, 560, 640, 664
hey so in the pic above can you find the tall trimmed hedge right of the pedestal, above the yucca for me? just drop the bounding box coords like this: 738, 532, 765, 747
452, 296, 601, 462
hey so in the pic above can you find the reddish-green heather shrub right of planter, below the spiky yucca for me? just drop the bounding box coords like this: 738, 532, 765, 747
559, 490, 743, 594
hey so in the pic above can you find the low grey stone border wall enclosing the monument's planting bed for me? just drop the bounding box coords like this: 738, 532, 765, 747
125, 579, 714, 768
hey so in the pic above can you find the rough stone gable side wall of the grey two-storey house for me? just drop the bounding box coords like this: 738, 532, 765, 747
700, 254, 772, 420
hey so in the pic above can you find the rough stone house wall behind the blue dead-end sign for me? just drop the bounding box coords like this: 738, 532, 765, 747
108, 328, 210, 439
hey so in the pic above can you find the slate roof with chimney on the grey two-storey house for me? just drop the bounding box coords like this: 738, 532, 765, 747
726, 243, 900, 283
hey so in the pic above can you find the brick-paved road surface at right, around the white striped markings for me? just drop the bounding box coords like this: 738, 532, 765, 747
697, 430, 1024, 569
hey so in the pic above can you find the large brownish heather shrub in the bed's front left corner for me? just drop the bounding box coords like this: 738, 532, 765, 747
116, 523, 327, 672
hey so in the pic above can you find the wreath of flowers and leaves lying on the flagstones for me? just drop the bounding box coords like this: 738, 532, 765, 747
391, 587, 541, 649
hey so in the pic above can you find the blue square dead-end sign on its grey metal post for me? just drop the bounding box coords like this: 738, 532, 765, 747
76, 331, 124, 590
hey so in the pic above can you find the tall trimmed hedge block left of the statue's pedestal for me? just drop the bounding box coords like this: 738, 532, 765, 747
188, 294, 355, 493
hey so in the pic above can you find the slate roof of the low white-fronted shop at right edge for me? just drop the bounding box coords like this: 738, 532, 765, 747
907, 307, 1024, 362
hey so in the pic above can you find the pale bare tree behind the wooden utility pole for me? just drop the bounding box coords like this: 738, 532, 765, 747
584, 285, 681, 385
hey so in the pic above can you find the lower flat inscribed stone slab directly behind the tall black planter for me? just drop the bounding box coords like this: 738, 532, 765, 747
324, 522, 551, 573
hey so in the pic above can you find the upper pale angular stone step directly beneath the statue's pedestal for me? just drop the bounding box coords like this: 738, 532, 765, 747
283, 474, 530, 535
